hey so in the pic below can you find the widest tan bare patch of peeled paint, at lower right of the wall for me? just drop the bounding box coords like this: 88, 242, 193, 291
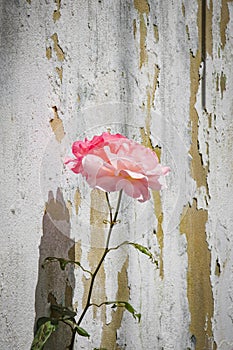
180, 199, 214, 350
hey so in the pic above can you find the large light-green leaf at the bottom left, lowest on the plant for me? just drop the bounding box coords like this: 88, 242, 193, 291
31, 317, 58, 350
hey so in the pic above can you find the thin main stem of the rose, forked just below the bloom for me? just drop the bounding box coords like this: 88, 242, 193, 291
77, 190, 122, 326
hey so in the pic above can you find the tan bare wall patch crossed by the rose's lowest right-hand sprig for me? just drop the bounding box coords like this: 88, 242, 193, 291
101, 258, 129, 350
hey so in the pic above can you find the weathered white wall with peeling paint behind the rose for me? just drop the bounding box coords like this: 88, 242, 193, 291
0, 0, 233, 350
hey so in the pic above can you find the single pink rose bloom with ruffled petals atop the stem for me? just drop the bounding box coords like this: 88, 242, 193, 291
65, 132, 170, 202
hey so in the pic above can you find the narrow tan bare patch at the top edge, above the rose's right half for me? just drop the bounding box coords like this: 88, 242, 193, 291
134, 0, 150, 69
